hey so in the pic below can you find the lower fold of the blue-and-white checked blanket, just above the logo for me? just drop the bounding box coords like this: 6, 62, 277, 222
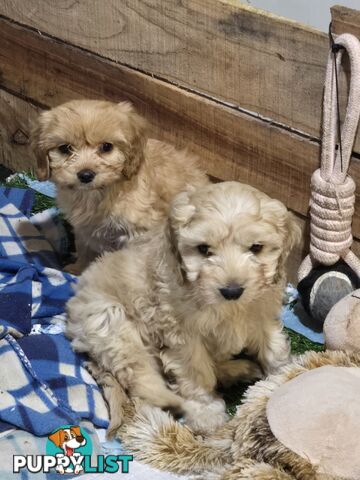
0, 334, 108, 435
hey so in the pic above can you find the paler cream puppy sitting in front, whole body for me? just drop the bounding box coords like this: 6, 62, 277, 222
67, 182, 300, 432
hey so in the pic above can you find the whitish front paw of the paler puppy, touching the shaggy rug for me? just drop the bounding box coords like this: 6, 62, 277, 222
184, 399, 228, 434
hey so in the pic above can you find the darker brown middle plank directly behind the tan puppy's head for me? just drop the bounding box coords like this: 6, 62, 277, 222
0, 19, 360, 235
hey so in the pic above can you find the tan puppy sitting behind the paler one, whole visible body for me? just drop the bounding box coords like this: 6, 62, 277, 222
32, 100, 208, 273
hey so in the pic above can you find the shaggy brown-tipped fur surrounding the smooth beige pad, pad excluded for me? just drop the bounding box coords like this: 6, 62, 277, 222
118, 352, 360, 480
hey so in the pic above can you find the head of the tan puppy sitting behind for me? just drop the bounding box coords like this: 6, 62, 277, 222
32, 100, 146, 189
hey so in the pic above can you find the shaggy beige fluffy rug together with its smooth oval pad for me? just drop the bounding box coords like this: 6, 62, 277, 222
118, 352, 360, 480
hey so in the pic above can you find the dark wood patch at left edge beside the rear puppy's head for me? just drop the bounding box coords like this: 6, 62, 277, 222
0, 90, 39, 171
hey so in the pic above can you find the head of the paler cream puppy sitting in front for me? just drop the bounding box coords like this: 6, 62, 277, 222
170, 182, 300, 304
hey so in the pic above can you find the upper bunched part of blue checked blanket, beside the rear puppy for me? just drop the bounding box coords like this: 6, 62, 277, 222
0, 189, 74, 334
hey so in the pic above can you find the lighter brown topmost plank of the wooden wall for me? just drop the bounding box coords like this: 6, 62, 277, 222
0, 0, 360, 151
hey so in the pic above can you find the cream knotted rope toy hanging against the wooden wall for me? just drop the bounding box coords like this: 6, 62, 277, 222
298, 33, 360, 281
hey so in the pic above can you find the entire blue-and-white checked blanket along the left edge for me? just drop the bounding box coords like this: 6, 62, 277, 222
0, 188, 108, 435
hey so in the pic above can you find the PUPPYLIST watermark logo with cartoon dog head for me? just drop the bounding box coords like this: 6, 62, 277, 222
13, 425, 133, 474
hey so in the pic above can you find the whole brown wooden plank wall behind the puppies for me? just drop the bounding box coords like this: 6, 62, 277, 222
0, 0, 360, 282
